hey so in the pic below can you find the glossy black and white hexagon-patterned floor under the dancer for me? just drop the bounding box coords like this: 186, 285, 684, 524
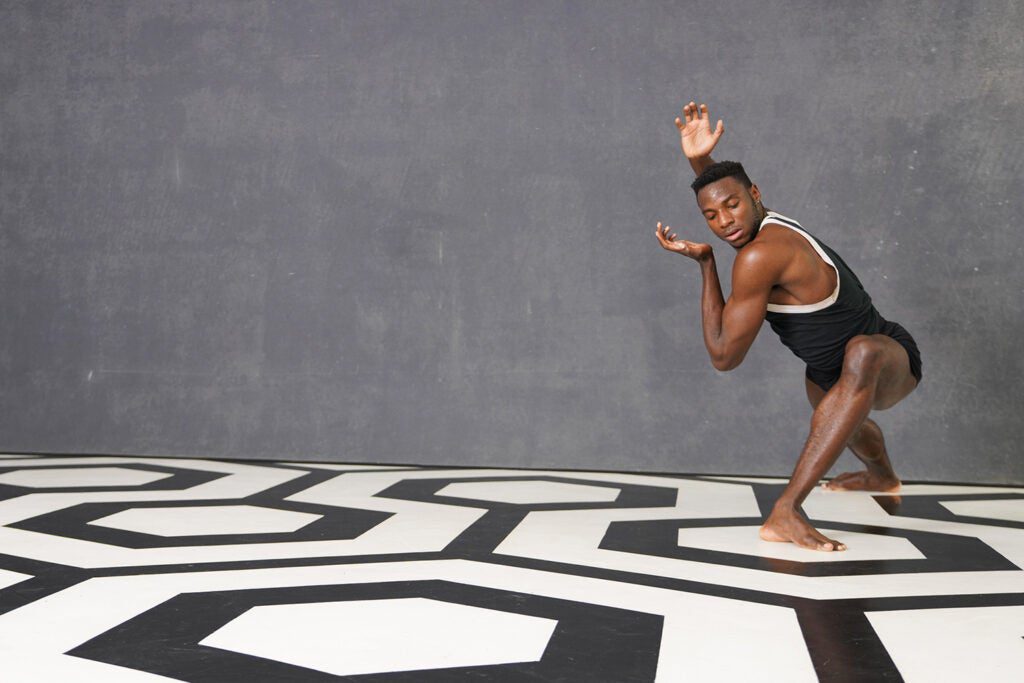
0, 456, 1024, 683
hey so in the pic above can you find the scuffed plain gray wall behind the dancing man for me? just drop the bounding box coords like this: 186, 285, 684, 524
0, 0, 1024, 483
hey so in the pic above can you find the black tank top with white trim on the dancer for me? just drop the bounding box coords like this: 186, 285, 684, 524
761, 211, 885, 372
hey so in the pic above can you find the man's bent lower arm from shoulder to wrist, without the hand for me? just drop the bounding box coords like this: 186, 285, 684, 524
700, 248, 780, 371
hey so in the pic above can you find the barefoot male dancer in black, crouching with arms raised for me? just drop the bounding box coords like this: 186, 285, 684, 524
657, 102, 921, 551
